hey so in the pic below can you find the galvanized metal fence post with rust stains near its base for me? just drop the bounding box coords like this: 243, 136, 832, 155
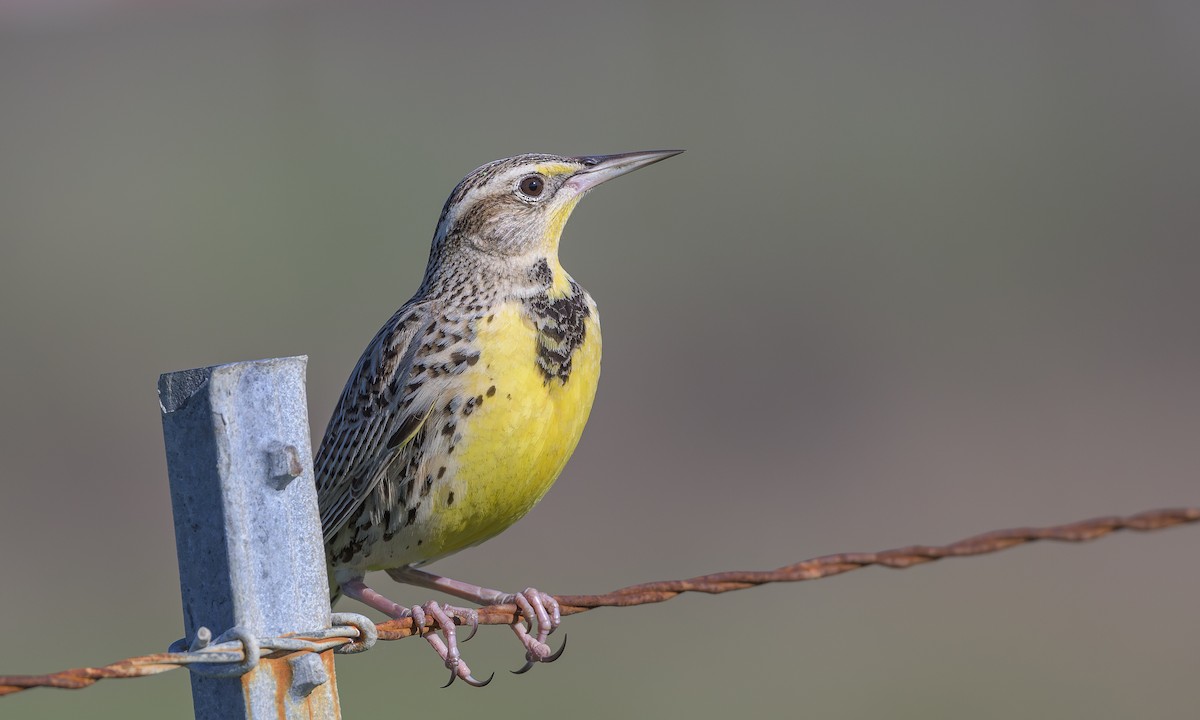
158, 356, 341, 720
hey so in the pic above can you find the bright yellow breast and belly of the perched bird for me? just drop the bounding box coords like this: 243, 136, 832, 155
421, 296, 600, 562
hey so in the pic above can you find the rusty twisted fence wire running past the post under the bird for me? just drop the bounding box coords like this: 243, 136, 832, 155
0, 508, 1200, 696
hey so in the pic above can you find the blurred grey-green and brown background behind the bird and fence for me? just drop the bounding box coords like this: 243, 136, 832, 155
0, 0, 1200, 719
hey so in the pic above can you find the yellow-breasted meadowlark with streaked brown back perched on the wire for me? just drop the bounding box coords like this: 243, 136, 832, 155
316, 150, 682, 685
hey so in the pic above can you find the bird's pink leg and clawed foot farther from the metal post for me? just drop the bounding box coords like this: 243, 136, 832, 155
388, 568, 566, 673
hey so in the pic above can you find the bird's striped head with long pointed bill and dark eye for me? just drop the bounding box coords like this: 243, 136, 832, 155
430, 150, 683, 284
